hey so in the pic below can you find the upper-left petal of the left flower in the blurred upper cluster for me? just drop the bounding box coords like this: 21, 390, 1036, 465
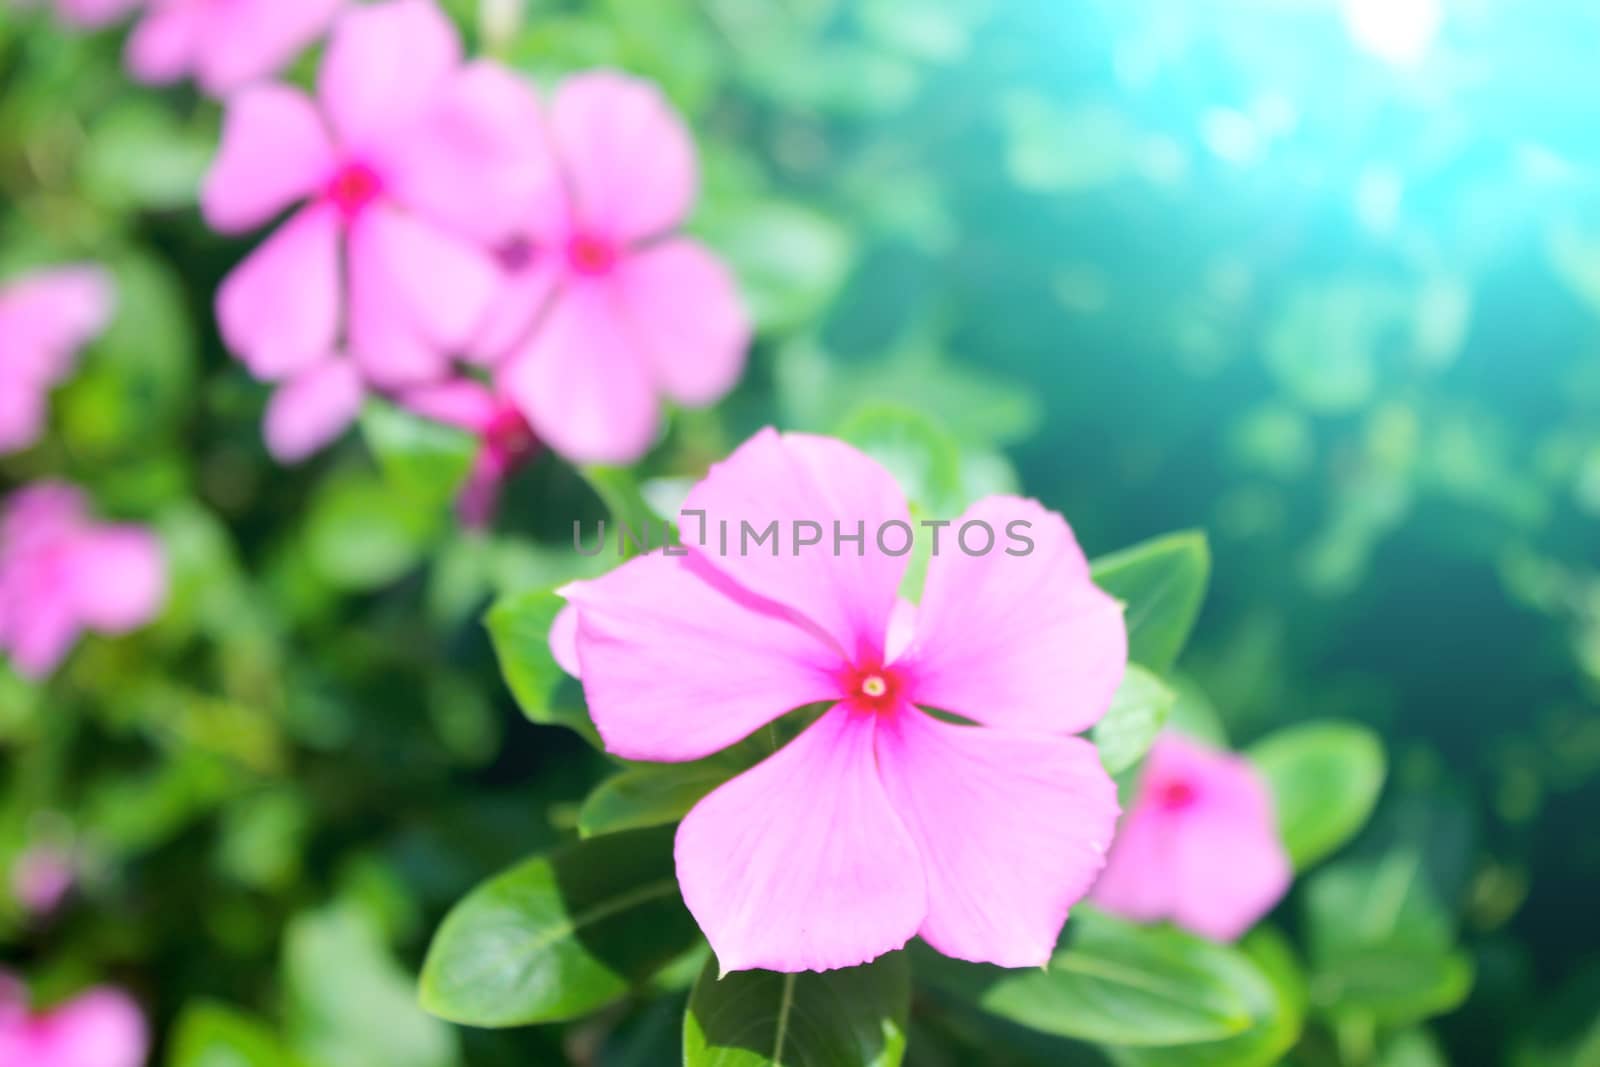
203, 84, 334, 234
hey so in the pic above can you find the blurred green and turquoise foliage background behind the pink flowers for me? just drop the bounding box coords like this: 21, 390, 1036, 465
0, 0, 1600, 1067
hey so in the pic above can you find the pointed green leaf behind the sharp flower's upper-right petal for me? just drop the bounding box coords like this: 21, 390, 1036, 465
1094, 531, 1211, 673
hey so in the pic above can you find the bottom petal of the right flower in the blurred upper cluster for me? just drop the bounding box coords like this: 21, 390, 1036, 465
501, 283, 661, 464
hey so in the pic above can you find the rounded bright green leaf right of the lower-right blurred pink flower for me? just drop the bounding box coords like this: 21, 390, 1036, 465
1246, 721, 1384, 870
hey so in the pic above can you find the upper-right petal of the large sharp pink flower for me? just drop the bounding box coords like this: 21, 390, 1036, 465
906, 496, 1128, 733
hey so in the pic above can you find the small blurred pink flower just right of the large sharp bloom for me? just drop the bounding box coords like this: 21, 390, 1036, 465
1094, 733, 1293, 941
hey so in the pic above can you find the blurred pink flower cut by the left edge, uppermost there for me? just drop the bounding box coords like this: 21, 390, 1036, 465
0, 267, 115, 453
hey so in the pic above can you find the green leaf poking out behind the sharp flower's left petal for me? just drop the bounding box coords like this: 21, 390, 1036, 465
483, 589, 598, 741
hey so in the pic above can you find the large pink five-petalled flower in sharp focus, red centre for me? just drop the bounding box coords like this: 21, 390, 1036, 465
566, 429, 1126, 971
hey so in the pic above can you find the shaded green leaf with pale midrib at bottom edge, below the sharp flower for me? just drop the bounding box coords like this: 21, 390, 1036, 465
683, 952, 910, 1067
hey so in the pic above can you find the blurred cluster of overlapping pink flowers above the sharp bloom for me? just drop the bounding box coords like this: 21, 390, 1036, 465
202, 0, 749, 518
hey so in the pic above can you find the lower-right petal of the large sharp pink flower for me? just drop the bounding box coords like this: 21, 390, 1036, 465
877, 707, 1117, 966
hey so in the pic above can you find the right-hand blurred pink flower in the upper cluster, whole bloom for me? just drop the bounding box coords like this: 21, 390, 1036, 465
478, 72, 750, 464
